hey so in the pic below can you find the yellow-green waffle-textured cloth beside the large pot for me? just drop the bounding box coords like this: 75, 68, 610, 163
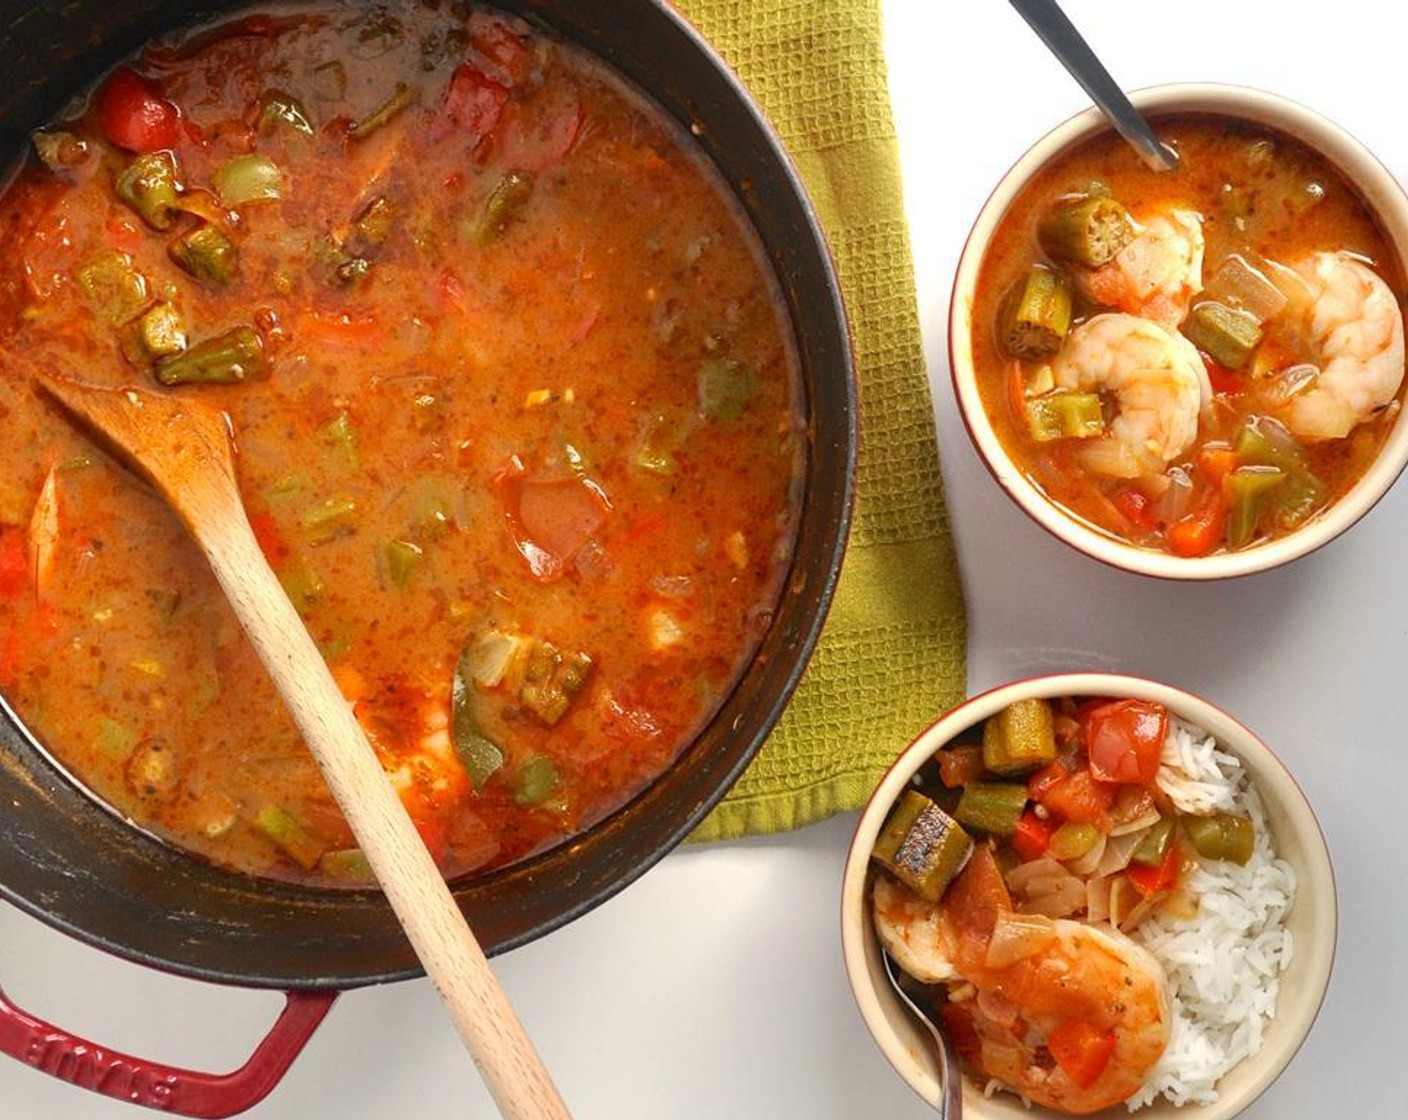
677, 0, 966, 840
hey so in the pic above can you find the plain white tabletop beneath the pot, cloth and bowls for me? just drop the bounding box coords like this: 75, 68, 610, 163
0, 0, 1408, 1120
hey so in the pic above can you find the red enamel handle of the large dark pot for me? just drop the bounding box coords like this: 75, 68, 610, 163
0, 989, 338, 1120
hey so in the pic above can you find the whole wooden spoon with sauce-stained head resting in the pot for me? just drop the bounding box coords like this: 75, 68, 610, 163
37, 375, 569, 1120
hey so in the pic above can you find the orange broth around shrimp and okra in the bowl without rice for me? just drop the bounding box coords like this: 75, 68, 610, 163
973, 114, 1405, 555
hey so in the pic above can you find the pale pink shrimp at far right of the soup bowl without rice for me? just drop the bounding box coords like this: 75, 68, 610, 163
1286, 252, 1404, 440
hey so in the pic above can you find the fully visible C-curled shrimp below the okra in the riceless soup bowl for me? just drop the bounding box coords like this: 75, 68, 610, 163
1052, 311, 1212, 478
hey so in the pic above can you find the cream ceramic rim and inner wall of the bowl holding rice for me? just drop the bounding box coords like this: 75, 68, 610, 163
841, 673, 1336, 1120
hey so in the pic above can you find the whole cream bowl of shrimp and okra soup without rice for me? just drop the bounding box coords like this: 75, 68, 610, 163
949, 86, 1408, 579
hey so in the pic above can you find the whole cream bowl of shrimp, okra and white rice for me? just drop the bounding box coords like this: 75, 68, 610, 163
842, 673, 1336, 1120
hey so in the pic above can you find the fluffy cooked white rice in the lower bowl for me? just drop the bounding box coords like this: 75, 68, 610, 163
1128, 720, 1295, 1112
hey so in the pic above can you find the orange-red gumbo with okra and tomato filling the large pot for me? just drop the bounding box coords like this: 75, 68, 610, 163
0, 4, 805, 883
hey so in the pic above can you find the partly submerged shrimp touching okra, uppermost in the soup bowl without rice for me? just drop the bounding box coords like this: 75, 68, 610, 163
1079, 210, 1202, 331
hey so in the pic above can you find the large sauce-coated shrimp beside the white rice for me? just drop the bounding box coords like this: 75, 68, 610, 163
872, 850, 1171, 1114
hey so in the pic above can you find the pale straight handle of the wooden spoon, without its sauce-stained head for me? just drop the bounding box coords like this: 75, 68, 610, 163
184, 479, 569, 1120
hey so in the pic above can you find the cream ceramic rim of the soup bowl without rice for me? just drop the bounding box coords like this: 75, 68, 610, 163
948, 83, 1408, 580
